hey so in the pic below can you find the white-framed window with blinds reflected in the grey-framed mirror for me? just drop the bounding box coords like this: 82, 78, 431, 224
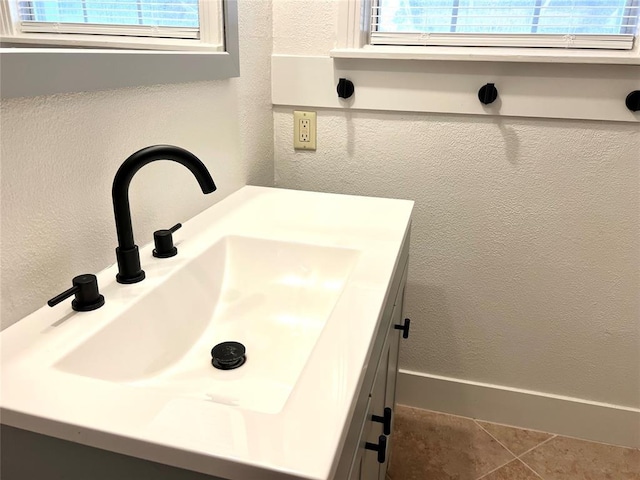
0, 0, 223, 50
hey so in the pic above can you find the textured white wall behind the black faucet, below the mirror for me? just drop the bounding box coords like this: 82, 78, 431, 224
0, 0, 273, 328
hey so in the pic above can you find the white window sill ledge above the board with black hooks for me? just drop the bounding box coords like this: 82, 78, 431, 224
330, 44, 640, 65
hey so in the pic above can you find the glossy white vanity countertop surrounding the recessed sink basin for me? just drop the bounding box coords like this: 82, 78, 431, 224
0, 187, 413, 480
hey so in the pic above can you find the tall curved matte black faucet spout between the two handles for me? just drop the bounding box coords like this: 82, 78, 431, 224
112, 145, 216, 283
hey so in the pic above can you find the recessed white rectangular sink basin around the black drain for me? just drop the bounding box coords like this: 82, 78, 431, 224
55, 236, 358, 413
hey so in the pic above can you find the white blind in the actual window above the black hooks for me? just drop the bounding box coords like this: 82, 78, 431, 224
370, 0, 640, 50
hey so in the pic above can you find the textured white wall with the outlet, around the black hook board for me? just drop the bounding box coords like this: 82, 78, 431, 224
274, 0, 640, 407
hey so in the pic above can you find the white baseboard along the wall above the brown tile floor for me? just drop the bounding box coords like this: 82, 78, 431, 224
396, 370, 640, 448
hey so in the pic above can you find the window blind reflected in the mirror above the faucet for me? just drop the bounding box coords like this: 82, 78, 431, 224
16, 0, 200, 39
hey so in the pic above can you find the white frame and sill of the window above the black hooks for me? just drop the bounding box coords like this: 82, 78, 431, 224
330, 0, 640, 65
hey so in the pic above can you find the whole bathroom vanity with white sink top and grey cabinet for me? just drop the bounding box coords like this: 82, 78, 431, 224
0, 187, 413, 480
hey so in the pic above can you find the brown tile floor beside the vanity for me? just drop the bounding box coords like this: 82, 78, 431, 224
387, 405, 640, 480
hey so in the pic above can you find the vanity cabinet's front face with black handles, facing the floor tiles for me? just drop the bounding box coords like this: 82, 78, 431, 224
334, 228, 409, 480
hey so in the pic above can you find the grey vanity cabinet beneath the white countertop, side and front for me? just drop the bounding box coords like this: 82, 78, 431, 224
1, 232, 409, 480
